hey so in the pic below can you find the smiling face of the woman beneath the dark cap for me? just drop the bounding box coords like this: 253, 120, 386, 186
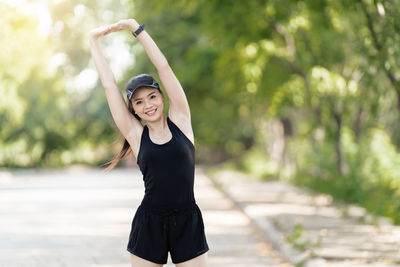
131, 87, 164, 121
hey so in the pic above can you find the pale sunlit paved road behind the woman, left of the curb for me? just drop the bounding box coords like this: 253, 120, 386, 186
0, 168, 291, 267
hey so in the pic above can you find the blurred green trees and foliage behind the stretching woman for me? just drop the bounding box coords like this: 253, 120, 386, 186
0, 0, 400, 224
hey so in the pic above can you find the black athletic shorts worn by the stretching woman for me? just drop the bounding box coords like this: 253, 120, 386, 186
127, 202, 209, 264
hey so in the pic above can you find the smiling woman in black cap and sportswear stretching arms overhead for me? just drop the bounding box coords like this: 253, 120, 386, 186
89, 19, 209, 267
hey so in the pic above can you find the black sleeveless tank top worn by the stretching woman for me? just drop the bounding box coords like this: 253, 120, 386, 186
137, 117, 195, 208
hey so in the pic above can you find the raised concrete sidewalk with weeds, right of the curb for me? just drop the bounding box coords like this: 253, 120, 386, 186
210, 170, 400, 267
